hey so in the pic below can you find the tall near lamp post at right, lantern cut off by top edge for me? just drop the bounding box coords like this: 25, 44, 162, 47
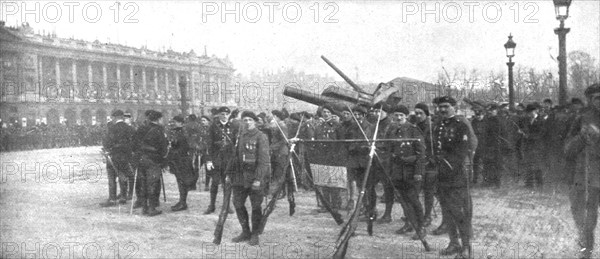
554, 0, 572, 105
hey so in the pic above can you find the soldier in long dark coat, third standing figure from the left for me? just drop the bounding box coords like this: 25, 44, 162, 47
167, 115, 198, 211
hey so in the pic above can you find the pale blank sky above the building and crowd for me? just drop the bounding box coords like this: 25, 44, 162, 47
0, 0, 600, 83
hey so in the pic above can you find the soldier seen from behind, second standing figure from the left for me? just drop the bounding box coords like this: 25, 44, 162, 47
134, 110, 168, 216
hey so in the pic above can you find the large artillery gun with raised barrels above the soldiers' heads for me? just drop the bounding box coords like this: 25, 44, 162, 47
283, 56, 402, 111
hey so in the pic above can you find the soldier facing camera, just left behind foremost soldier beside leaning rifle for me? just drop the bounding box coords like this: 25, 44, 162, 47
204, 106, 239, 214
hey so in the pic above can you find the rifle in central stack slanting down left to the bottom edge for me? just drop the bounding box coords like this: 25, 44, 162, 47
333, 112, 381, 258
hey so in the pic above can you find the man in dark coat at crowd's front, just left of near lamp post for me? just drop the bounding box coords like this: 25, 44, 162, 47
519, 103, 546, 188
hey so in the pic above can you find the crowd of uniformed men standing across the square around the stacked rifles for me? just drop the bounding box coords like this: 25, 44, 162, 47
96, 85, 600, 258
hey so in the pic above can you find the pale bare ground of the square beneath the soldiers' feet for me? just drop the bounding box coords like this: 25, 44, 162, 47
0, 147, 597, 258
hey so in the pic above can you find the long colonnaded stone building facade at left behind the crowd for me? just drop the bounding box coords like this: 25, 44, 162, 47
0, 21, 238, 125
